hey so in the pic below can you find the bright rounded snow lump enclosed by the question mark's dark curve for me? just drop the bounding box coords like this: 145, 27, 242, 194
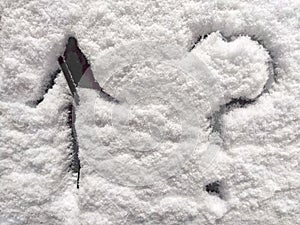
193, 33, 270, 102
